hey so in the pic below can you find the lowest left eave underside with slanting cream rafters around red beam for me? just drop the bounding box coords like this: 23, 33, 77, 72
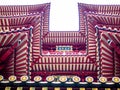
0, 29, 28, 78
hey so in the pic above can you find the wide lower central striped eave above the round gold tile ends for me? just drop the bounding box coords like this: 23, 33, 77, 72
33, 56, 96, 73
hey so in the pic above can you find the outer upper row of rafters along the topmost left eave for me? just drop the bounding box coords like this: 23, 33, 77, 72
0, 3, 50, 12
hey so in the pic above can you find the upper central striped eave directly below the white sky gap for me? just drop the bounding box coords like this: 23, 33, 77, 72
43, 32, 86, 44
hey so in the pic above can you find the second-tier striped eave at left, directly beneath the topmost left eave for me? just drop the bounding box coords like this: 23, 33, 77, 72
0, 13, 42, 32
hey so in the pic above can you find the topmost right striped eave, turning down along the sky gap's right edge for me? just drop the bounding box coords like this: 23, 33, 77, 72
78, 3, 120, 34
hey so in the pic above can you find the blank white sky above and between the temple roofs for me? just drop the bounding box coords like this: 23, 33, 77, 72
0, 0, 120, 31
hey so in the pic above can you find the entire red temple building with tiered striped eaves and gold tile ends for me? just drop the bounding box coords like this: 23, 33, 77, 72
0, 3, 120, 90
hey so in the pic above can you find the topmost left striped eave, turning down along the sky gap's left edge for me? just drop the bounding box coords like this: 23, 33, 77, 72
0, 3, 50, 34
